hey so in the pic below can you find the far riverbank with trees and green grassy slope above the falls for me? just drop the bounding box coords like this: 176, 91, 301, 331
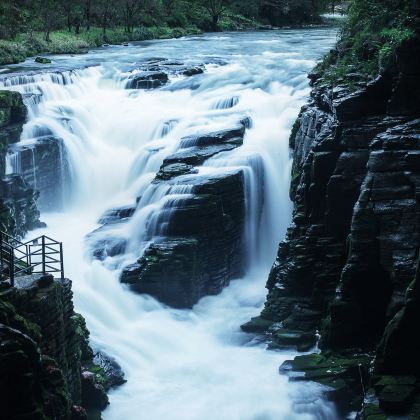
0, 0, 339, 65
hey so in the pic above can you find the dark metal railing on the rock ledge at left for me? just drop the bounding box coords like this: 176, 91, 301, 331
0, 231, 64, 286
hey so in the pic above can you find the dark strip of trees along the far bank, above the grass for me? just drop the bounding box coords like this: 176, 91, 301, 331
0, 0, 337, 40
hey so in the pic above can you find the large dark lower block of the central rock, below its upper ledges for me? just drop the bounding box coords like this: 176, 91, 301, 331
121, 171, 244, 308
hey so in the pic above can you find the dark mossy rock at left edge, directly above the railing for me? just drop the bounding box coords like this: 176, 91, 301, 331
0, 91, 40, 237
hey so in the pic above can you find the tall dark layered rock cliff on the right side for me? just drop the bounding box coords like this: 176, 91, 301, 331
243, 34, 420, 419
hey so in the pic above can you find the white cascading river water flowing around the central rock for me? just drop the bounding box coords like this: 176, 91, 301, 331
4, 29, 336, 420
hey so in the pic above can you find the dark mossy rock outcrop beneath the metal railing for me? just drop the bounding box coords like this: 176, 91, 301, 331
0, 275, 124, 420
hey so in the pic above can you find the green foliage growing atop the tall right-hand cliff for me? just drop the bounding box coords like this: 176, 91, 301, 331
317, 0, 420, 88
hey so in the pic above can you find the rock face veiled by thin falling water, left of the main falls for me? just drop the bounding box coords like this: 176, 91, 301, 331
9, 136, 70, 211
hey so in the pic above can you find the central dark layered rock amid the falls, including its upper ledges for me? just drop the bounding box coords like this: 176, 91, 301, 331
121, 123, 245, 308
